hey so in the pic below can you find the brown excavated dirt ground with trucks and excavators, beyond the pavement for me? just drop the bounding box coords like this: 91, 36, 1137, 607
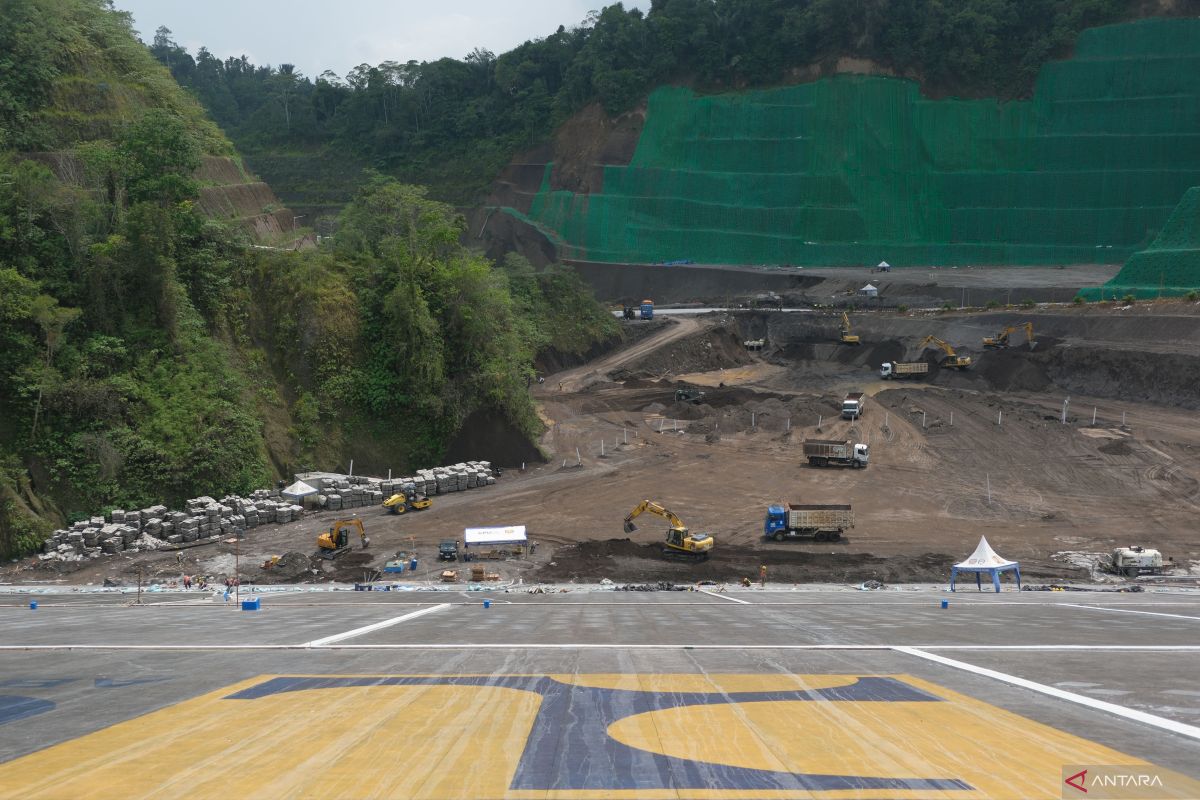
6, 293, 1200, 584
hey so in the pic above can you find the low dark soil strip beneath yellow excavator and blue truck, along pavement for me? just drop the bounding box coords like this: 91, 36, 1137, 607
533, 539, 993, 583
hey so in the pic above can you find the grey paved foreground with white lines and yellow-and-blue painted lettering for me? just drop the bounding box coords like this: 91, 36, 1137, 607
0, 583, 1200, 800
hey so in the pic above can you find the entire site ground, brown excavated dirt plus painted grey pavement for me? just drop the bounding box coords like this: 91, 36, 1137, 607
0, 280, 1200, 800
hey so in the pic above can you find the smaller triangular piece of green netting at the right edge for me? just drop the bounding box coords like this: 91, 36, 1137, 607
1081, 186, 1200, 300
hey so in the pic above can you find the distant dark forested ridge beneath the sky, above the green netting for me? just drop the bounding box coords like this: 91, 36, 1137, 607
142, 0, 1171, 209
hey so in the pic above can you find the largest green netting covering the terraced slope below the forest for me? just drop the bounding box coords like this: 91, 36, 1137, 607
530, 19, 1200, 265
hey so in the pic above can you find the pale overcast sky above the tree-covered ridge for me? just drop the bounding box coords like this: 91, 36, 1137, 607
114, 0, 650, 78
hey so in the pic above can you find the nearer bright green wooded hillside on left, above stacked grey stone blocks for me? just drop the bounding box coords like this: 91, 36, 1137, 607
0, 0, 616, 555
